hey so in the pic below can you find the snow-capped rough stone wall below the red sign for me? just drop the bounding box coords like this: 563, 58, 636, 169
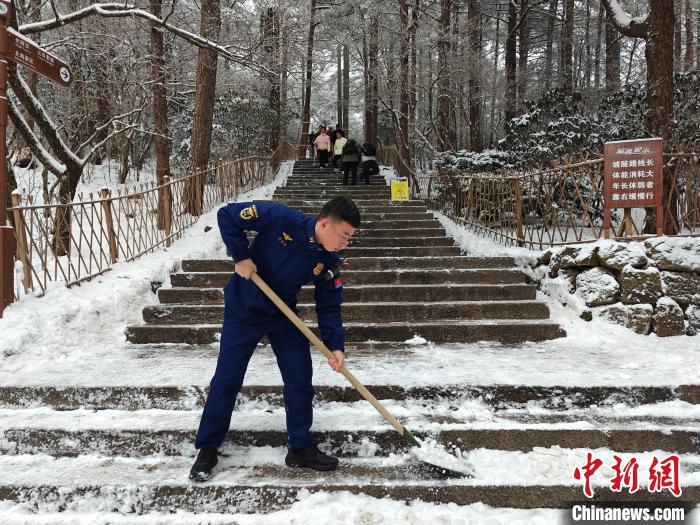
530, 237, 700, 336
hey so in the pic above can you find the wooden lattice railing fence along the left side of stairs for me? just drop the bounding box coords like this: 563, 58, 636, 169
8, 142, 296, 298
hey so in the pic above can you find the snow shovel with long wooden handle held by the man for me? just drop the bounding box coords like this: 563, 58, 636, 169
251, 273, 472, 478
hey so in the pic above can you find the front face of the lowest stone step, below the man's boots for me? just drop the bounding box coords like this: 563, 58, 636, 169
0, 482, 700, 510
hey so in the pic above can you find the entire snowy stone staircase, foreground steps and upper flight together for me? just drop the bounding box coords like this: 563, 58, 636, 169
0, 161, 700, 523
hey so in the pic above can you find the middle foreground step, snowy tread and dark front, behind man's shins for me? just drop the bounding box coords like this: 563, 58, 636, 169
5, 414, 700, 457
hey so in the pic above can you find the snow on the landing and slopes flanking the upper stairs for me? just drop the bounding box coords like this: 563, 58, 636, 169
0, 163, 700, 386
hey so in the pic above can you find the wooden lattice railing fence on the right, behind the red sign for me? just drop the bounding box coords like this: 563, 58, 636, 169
379, 146, 700, 249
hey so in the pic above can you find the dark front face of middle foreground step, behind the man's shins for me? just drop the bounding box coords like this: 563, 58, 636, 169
5, 426, 700, 457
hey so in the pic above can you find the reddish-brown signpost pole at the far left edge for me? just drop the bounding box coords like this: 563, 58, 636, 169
0, 13, 15, 318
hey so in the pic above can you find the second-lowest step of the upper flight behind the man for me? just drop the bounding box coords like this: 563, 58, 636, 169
143, 301, 549, 324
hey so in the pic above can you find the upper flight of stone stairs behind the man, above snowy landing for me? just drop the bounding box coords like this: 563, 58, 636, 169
127, 161, 565, 347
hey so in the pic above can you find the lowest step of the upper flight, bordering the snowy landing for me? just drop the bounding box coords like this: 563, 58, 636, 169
126, 319, 566, 344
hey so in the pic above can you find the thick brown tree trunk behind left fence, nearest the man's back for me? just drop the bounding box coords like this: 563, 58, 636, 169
185, 0, 221, 215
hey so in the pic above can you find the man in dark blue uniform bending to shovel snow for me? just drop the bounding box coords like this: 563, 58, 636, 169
190, 197, 360, 481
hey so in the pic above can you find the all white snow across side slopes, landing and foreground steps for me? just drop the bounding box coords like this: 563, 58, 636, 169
0, 163, 700, 525
